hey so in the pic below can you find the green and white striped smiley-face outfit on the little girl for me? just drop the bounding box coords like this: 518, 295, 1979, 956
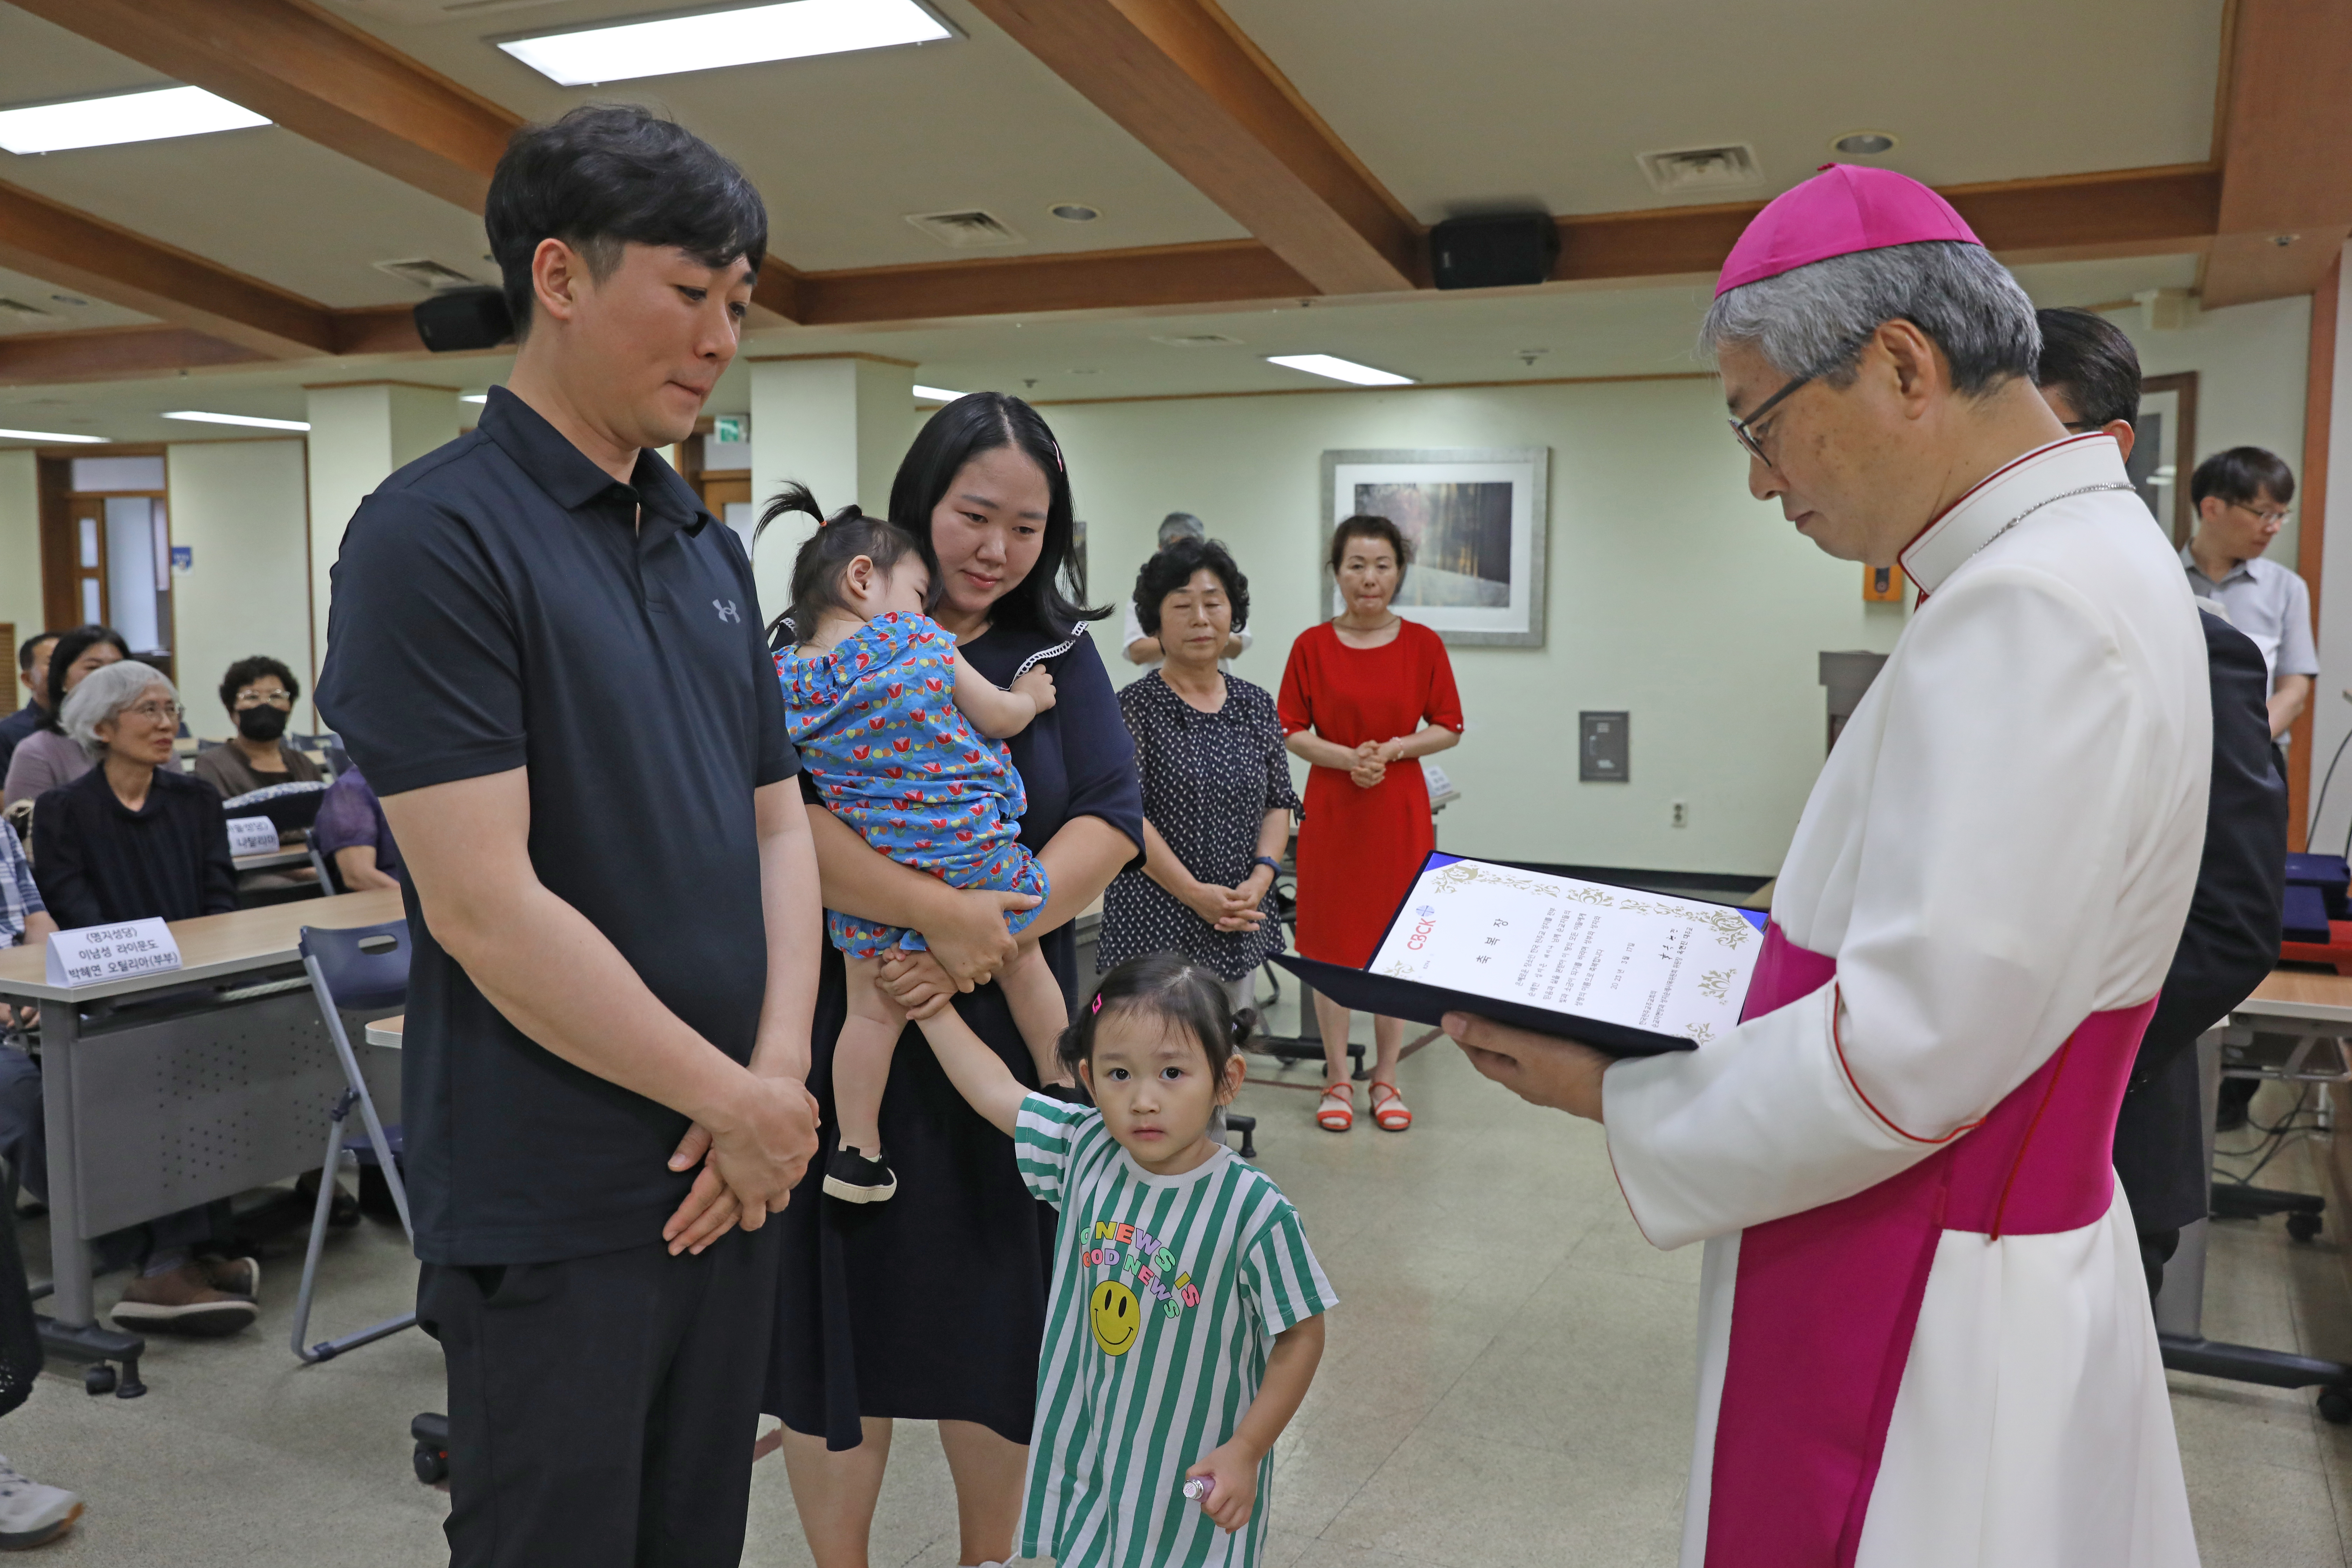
1014, 1096, 1338, 1568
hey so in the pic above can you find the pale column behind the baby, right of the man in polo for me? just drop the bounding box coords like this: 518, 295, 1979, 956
750, 355, 920, 618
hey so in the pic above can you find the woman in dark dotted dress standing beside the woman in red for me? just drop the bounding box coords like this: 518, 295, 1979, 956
1094, 538, 1298, 1008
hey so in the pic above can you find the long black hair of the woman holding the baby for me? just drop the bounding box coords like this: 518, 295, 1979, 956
889, 393, 1110, 639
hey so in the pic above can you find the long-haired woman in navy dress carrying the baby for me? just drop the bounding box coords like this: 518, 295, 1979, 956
760, 393, 1143, 1568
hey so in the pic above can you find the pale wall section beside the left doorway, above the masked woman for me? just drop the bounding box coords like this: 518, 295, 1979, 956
164, 440, 313, 738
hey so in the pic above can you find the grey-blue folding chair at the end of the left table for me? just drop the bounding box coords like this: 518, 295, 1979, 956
292, 919, 416, 1364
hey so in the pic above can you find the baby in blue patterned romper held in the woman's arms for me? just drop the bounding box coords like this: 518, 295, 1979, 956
769, 489, 1070, 1204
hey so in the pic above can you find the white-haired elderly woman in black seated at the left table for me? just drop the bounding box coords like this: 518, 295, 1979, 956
18, 658, 261, 1335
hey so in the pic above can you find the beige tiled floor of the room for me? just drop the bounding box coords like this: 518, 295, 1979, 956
0, 1044, 2352, 1568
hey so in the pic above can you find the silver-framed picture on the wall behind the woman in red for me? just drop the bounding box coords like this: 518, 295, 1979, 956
1315, 447, 1552, 649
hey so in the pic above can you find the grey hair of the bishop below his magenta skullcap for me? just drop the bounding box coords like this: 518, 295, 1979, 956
1698, 240, 2042, 397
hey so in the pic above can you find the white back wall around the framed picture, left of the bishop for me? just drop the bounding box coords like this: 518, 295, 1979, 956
1044, 378, 1903, 875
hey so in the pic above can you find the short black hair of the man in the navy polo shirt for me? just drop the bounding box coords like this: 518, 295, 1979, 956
482, 104, 767, 343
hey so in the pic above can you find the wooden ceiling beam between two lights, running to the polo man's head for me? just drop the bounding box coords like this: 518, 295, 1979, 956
12, 0, 522, 211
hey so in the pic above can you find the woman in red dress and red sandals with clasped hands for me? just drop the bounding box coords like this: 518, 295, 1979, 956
1277, 515, 1463, 1133
